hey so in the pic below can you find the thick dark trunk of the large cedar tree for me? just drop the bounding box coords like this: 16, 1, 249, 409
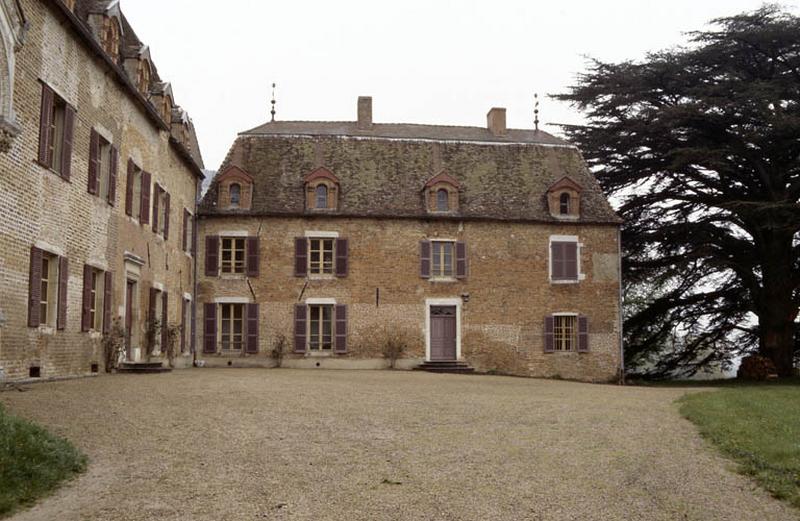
758, 230, 798, 377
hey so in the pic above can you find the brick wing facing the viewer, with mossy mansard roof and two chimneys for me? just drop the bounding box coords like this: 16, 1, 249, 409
197, 98, 621, 381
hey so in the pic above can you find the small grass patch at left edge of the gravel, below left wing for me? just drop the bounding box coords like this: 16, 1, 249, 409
0, 405, 86, 518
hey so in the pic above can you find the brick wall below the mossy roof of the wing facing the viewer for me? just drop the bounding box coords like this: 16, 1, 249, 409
196, 216, 620, 381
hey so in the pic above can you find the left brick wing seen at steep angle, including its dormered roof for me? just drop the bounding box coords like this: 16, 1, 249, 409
0, 0, 203, 380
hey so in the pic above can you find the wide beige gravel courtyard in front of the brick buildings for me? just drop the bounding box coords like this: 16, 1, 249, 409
0, 369, 798, 521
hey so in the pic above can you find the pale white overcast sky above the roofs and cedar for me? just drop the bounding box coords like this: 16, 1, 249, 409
121, 0, 797, 170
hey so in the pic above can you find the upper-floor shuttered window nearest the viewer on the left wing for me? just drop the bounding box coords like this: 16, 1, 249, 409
39, 85, 75, 180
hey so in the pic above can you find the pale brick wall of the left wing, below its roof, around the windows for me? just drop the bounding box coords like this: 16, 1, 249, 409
0, 0, 196, 379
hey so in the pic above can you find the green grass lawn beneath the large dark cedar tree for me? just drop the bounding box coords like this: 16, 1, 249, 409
680, 380, 800, 508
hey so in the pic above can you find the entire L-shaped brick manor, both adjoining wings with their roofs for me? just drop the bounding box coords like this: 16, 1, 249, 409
0, 0, 622, 381
